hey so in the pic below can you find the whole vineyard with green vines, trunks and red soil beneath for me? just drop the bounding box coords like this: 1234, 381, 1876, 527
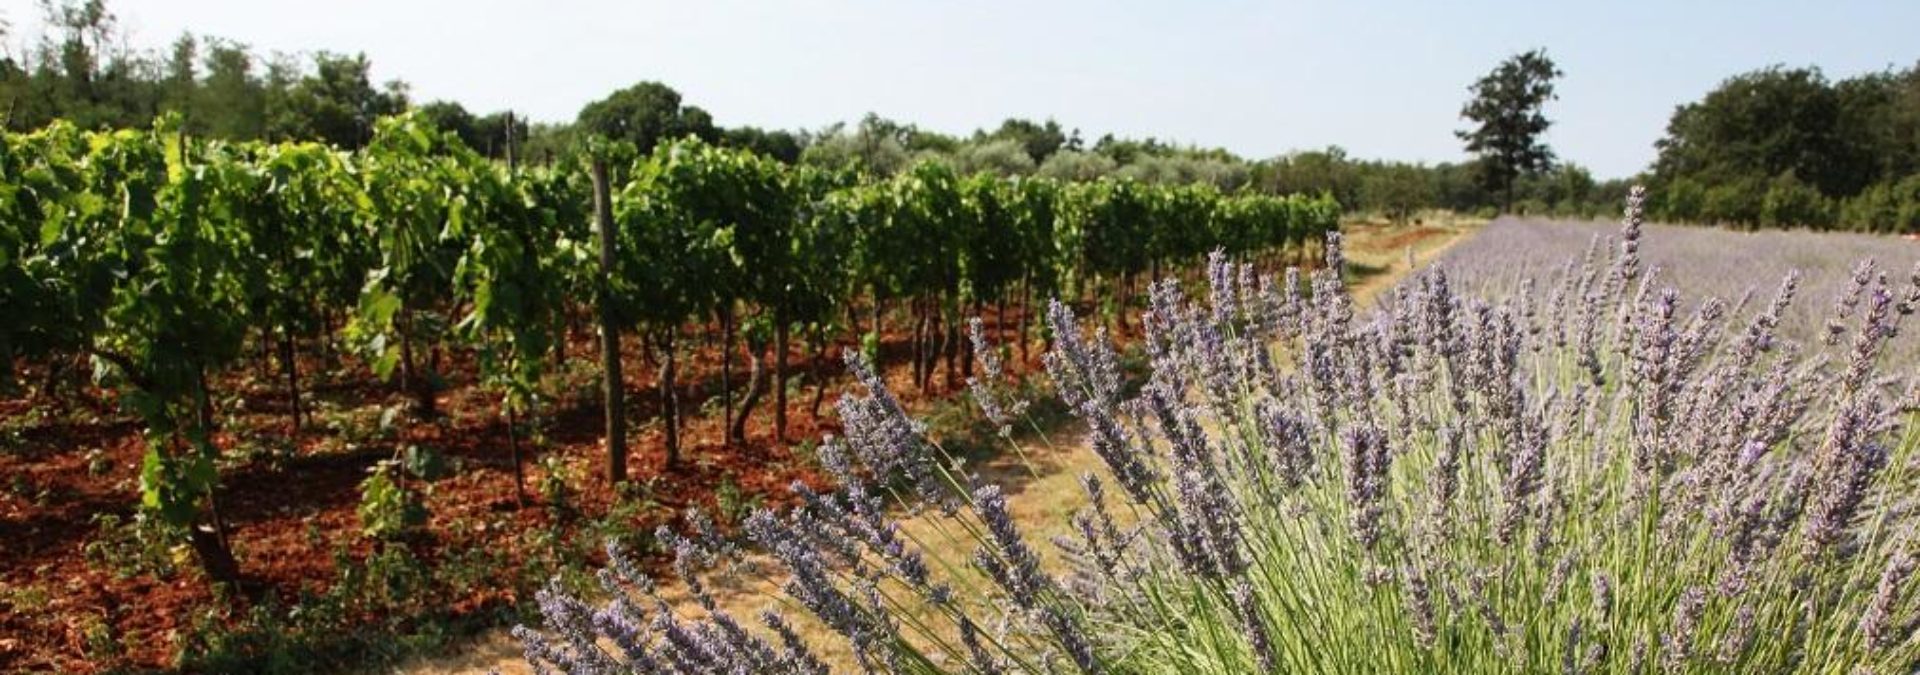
0, 115, 1338, 667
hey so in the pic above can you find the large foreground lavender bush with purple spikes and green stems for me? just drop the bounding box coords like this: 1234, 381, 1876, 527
518, 192, 1920, 673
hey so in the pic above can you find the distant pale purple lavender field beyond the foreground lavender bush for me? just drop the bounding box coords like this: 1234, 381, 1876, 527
1434, 219, 1920, 364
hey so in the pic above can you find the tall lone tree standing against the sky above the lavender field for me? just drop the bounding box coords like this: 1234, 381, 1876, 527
1453, 50, 1563, 209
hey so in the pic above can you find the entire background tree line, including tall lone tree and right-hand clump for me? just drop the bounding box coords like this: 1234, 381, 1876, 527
0, 0, 1920, 232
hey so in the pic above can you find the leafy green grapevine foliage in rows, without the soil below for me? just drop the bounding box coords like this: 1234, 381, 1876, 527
0, 111, 1340, 581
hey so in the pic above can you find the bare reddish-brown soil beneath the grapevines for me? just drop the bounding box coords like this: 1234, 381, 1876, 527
0, 306, 1041, 673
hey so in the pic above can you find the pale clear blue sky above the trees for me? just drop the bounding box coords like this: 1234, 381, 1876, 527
0, 0, 1920, 176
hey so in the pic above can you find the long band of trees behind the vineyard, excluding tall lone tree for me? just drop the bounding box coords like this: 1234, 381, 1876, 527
0, 0, 1543, 219
